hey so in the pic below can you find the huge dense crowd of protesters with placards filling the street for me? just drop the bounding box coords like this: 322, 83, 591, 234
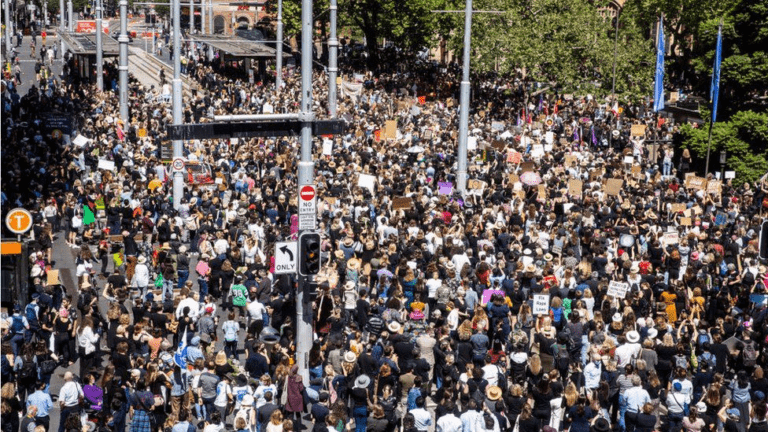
0, 33, 768, 432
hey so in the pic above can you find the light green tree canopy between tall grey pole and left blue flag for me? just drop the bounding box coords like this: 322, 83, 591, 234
451, 0, 654, 96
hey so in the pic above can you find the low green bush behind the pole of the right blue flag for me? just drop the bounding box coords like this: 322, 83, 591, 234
681, 111, 768, 185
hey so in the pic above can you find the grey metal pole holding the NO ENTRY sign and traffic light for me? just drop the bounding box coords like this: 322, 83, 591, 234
296, 0, 315, 385
